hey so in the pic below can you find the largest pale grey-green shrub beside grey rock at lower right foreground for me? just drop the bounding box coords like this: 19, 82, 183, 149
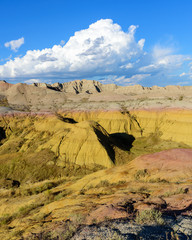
135, 209, 164, 225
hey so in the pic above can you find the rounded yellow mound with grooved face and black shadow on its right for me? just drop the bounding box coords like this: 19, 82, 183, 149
35, 118, 114, 167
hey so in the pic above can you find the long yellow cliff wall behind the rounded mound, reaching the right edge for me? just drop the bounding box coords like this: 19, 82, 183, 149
61, 109, 192, 146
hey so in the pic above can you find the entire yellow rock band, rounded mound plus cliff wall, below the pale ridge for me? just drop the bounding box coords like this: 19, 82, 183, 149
0, 109, 192, 167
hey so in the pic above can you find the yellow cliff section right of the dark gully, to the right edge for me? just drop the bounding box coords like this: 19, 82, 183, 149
131, 109, 192, 146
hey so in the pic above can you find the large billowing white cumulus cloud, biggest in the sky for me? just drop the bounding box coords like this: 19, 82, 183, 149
0, 19, 144, 78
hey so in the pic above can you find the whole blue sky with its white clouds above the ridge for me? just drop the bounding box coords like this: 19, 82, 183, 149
0, 0, 192, 87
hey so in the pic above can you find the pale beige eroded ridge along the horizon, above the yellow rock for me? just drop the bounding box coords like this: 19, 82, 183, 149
0, 80, 192, 112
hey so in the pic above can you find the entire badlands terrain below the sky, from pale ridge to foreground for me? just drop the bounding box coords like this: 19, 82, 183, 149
0, 80, 192, 240
